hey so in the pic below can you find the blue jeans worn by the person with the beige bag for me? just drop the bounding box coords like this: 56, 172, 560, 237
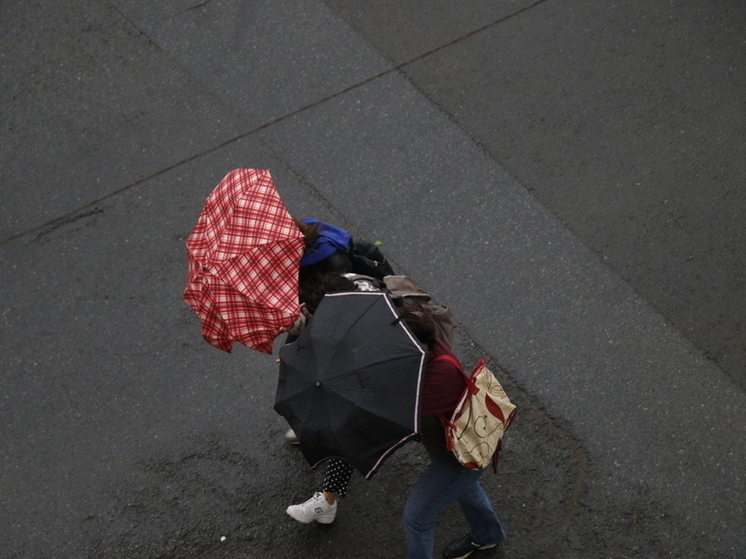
404, 454, 505, 559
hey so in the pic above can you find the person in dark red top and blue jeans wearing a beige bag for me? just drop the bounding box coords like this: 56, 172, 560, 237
403, 309, 505, 559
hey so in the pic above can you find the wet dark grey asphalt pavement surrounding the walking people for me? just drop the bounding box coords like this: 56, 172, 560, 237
0, 0, 746, 559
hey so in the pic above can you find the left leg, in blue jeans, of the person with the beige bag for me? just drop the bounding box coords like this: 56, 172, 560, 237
404, 455, 479, 559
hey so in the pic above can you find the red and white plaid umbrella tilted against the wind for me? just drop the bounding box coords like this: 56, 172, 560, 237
183, 169, 303, 353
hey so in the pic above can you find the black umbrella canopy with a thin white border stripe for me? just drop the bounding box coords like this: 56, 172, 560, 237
275, 292, 425, 478
